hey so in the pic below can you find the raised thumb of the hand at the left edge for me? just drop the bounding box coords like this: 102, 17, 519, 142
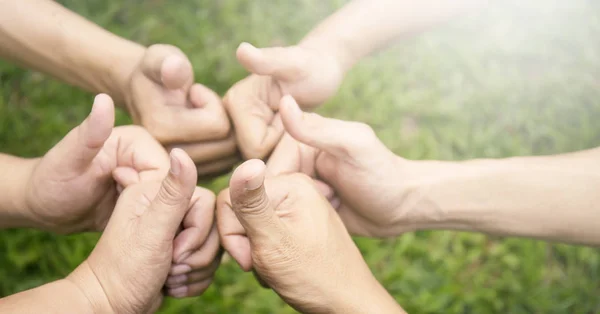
51, 94, 115, 172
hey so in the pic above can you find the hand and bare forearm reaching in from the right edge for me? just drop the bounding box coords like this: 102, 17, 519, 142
267, 96, 600, 246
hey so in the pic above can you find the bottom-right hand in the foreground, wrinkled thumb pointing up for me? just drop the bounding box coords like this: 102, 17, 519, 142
217, 160, 399, 313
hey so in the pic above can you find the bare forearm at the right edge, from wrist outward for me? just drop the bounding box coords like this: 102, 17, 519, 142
401, 149, 600, 246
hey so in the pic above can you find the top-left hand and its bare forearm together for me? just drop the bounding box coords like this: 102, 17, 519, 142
0, 0, 238, 176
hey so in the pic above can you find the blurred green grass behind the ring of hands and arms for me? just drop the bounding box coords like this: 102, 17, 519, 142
0, 0, 600, 313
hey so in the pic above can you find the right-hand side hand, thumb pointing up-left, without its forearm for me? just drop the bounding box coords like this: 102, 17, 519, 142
267, 96, 410, 237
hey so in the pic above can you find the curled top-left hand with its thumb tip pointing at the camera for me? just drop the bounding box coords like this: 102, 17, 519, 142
123, 45, 239, 176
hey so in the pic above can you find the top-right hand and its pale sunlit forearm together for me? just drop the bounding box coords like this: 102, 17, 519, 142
223, 0, 480, 158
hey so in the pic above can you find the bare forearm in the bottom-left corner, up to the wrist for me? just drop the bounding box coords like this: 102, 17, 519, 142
0, 262, 114, 314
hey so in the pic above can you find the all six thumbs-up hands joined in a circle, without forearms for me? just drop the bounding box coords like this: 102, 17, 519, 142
22, 43, 410, 313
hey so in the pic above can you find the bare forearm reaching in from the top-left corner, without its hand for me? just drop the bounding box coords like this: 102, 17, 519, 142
0, 0, 144, 103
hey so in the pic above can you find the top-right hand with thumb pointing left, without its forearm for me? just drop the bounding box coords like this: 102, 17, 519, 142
223, 43, 344, 158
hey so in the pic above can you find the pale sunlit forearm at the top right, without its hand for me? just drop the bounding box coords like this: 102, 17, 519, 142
301, 0, 486, 70
